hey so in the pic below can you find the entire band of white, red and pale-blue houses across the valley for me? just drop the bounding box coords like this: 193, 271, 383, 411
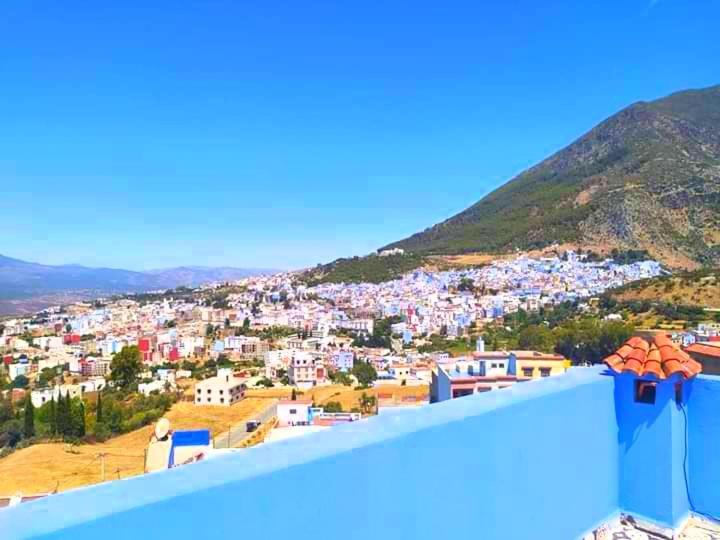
0, 252, 664, 405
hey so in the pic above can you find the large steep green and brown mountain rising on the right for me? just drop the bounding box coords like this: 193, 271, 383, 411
383, 86, 720, 268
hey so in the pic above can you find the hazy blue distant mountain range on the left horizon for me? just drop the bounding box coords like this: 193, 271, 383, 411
0, 255, 277, 314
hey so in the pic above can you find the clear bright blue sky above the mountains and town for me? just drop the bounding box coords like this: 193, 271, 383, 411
0, 0, 720, 269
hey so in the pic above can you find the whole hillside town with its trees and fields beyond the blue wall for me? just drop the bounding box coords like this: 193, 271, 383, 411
0, 251, 720, 496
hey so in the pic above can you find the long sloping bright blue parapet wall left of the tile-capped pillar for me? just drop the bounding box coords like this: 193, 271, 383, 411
0, 369, 620, 540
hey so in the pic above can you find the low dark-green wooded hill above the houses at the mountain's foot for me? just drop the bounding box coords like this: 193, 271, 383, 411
300, 253, 426, 286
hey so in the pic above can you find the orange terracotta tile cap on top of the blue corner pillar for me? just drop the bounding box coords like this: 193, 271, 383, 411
605, 334, 702, 379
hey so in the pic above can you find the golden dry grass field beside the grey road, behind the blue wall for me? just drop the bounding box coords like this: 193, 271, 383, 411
0, 397, 267, 496
